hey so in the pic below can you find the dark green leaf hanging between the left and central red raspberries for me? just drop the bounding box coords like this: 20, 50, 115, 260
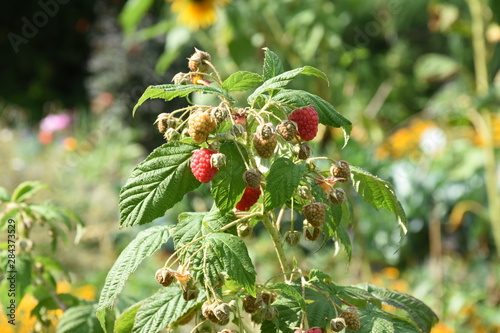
212, 142, 248, 214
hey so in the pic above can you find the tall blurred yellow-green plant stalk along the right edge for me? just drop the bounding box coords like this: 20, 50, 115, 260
467, 0, 500, 255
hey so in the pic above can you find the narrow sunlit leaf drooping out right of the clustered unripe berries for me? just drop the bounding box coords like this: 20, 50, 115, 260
351, 166, 408, 241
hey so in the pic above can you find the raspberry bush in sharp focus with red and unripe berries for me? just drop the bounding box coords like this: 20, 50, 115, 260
97, 49, 437, 333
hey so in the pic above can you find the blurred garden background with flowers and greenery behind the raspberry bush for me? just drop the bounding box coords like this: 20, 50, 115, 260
0, 0, 500, 333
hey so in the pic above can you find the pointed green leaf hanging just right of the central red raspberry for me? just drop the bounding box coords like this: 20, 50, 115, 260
264, 158, 307, 211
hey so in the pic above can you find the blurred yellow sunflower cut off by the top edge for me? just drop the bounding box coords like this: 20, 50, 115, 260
168, 0, 231, 30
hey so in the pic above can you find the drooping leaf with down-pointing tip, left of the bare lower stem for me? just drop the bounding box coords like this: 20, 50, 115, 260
199, 233, 256, 295
